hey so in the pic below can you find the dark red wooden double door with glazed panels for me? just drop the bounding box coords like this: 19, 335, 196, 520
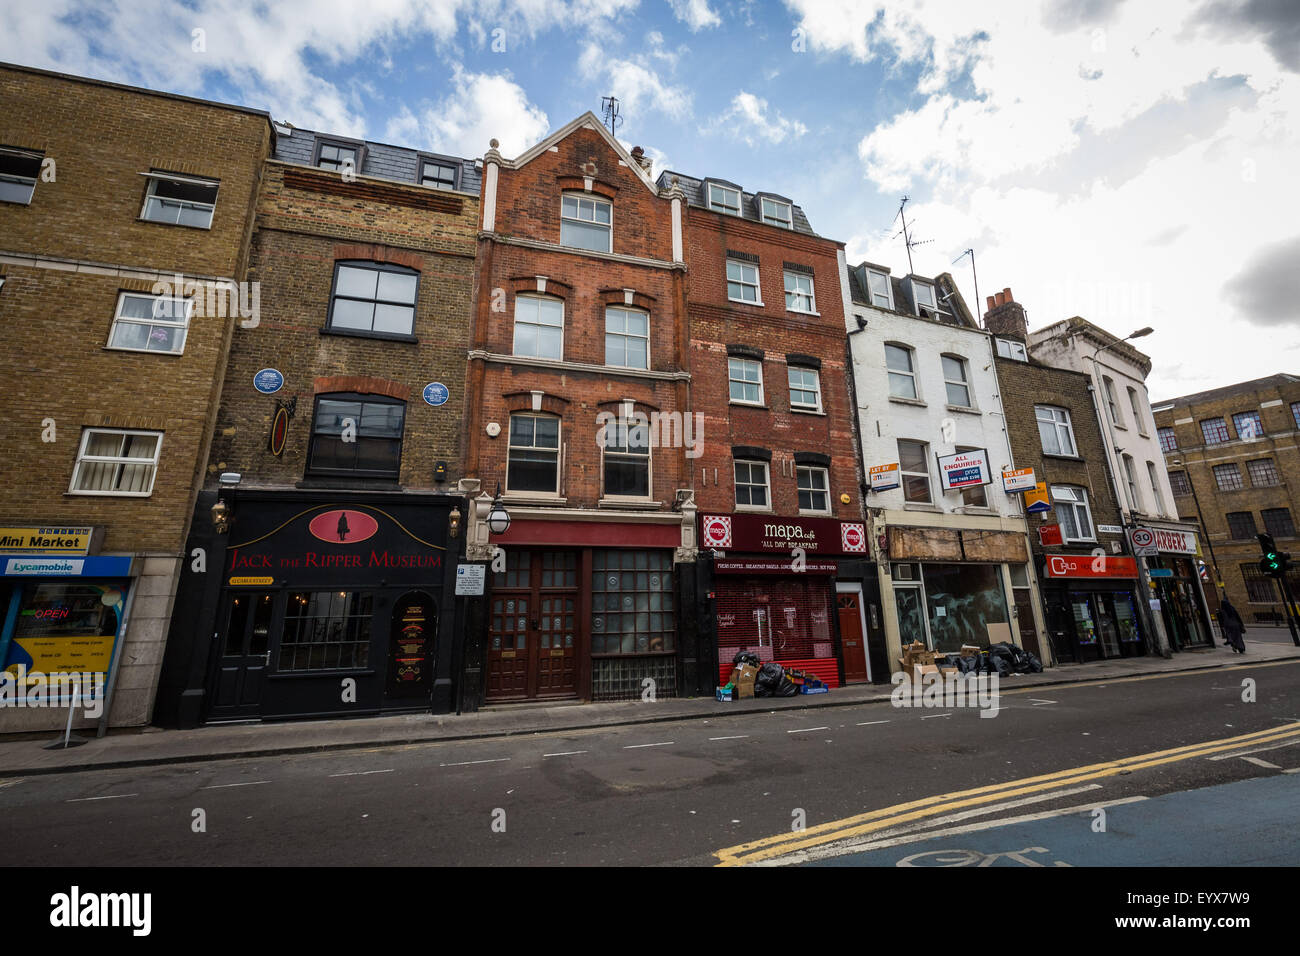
486, 549, 581, 701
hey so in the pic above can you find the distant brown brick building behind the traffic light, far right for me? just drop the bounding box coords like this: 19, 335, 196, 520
1152, 375, 1300, 624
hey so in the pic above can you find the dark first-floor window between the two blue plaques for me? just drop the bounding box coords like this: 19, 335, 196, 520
307, 394, 406, 479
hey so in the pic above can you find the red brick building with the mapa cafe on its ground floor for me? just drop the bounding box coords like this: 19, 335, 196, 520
659, 173, 875, 693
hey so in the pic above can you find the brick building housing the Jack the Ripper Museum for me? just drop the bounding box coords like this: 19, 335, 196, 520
160, 126, 480, 726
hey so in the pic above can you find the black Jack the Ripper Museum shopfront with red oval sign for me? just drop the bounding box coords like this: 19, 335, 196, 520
159, 490, 463, 726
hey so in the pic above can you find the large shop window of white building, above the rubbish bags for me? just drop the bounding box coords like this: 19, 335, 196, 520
920, 564, 1010, 653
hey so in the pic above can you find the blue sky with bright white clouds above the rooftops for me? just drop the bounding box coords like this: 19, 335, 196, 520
0, 0, 1300, 401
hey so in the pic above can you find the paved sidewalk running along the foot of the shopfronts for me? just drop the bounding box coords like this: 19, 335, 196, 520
0, 627, 1300, 779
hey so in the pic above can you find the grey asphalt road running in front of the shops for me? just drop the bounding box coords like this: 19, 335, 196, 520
0, 662, 1300, 866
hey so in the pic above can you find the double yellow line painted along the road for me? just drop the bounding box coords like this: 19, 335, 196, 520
714, 722, 1300, 866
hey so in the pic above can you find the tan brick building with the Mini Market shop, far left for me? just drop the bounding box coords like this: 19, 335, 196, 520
0, 66, 273, 731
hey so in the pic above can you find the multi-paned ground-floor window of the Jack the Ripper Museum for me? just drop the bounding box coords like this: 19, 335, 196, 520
278, 591, 373, 671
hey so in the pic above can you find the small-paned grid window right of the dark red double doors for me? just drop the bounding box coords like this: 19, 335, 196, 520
592, 550, 676, 654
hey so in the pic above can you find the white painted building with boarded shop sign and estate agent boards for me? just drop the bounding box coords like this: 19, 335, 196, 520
841, 259, 1043, 671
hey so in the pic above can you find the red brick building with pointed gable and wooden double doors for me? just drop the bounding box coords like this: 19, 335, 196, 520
462, 113, 694, 706
